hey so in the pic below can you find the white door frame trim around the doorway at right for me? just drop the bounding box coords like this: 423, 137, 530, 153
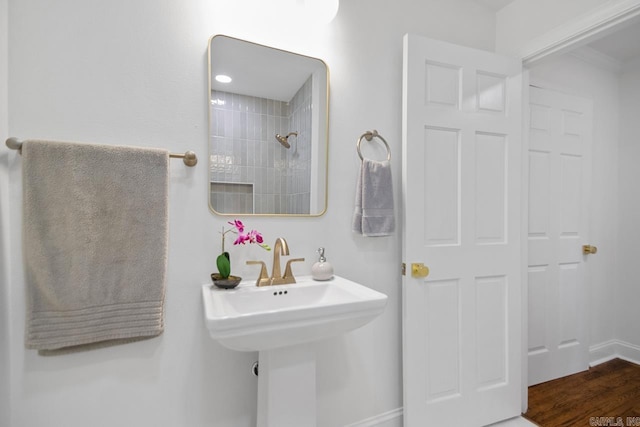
518, 0, 640, 413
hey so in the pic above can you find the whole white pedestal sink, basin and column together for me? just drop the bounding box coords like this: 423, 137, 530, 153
202, 276, 387, 427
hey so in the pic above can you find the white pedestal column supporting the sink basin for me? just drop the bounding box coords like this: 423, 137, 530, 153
257, 344, 316, 427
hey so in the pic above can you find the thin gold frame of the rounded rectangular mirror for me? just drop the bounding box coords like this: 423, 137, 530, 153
207, 34, 330, 218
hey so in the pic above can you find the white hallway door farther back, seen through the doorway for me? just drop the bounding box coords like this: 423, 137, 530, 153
528, 87, 593, 385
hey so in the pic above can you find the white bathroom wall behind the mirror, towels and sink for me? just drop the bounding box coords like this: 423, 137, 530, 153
0, 0, 495, 427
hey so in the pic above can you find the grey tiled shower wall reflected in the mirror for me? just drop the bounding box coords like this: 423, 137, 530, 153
210, 78, 312, 214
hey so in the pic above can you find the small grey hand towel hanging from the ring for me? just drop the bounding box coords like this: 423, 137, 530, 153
353, 159, 396, 237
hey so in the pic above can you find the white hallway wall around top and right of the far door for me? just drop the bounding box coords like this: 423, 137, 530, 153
531, 55, 625, 358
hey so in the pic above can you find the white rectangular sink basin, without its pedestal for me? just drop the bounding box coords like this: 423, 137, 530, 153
202, 276, 387, 351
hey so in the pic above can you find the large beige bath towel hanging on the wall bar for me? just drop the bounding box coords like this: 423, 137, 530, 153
22, 141, 169, 352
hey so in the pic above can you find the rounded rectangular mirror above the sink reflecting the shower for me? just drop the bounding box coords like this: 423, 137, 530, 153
209, 35, 329, 216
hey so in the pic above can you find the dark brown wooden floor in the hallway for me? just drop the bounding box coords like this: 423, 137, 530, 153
524, 359, 640, 427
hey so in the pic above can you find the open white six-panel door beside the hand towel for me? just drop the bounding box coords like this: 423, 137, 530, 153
402, 35, 522, 427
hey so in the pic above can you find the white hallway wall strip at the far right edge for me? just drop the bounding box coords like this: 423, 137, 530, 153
613, 58, 640, 357
